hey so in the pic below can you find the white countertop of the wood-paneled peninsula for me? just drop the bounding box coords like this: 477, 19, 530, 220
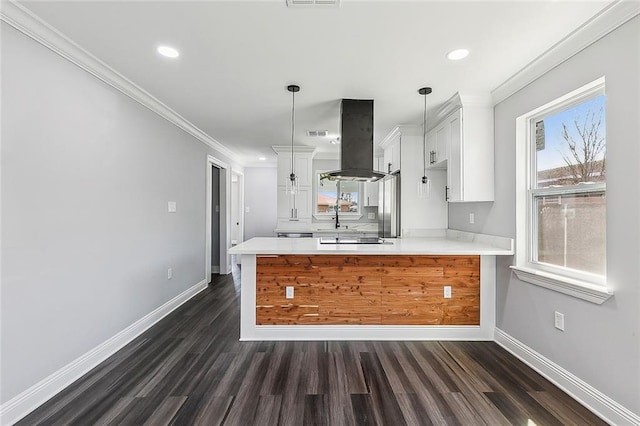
229, 230, 514, 255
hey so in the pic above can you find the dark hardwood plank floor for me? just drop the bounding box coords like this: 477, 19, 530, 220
19, 269, 605, 425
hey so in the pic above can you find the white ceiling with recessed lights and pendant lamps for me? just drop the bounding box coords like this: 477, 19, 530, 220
21, 0, 611, 164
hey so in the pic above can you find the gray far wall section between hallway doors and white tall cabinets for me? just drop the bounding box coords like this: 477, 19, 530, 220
244, 167, 278, 241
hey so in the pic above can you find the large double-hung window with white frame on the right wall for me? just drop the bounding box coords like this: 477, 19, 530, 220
514, 78, 610, 303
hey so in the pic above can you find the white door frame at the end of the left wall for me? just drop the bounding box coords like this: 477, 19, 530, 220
204, 155, 231, 280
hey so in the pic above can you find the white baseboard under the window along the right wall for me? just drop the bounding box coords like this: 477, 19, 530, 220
495, 328, 640, 425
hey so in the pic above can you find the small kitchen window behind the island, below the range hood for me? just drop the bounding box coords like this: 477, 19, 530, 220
315, 171, 360, 219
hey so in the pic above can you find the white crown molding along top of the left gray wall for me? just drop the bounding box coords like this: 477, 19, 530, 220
0, 0, 244, 165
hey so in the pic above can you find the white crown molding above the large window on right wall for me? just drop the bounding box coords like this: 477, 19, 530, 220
491, 0, 640, 105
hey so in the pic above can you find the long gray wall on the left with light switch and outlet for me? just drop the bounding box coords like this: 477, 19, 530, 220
0, 23, 240, 403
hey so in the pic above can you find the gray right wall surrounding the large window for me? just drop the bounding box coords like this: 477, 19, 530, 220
449, 17, 640, 414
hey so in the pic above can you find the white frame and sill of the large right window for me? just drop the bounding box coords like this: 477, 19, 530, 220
511, 77, 613, 304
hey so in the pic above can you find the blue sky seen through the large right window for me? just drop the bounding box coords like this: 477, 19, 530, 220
537, 95, 606, 170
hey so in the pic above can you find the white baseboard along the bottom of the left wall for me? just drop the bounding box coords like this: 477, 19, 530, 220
0, 279, 208, 425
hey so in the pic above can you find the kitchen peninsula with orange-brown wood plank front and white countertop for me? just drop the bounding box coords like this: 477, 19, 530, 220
230, 231, 513, 340
